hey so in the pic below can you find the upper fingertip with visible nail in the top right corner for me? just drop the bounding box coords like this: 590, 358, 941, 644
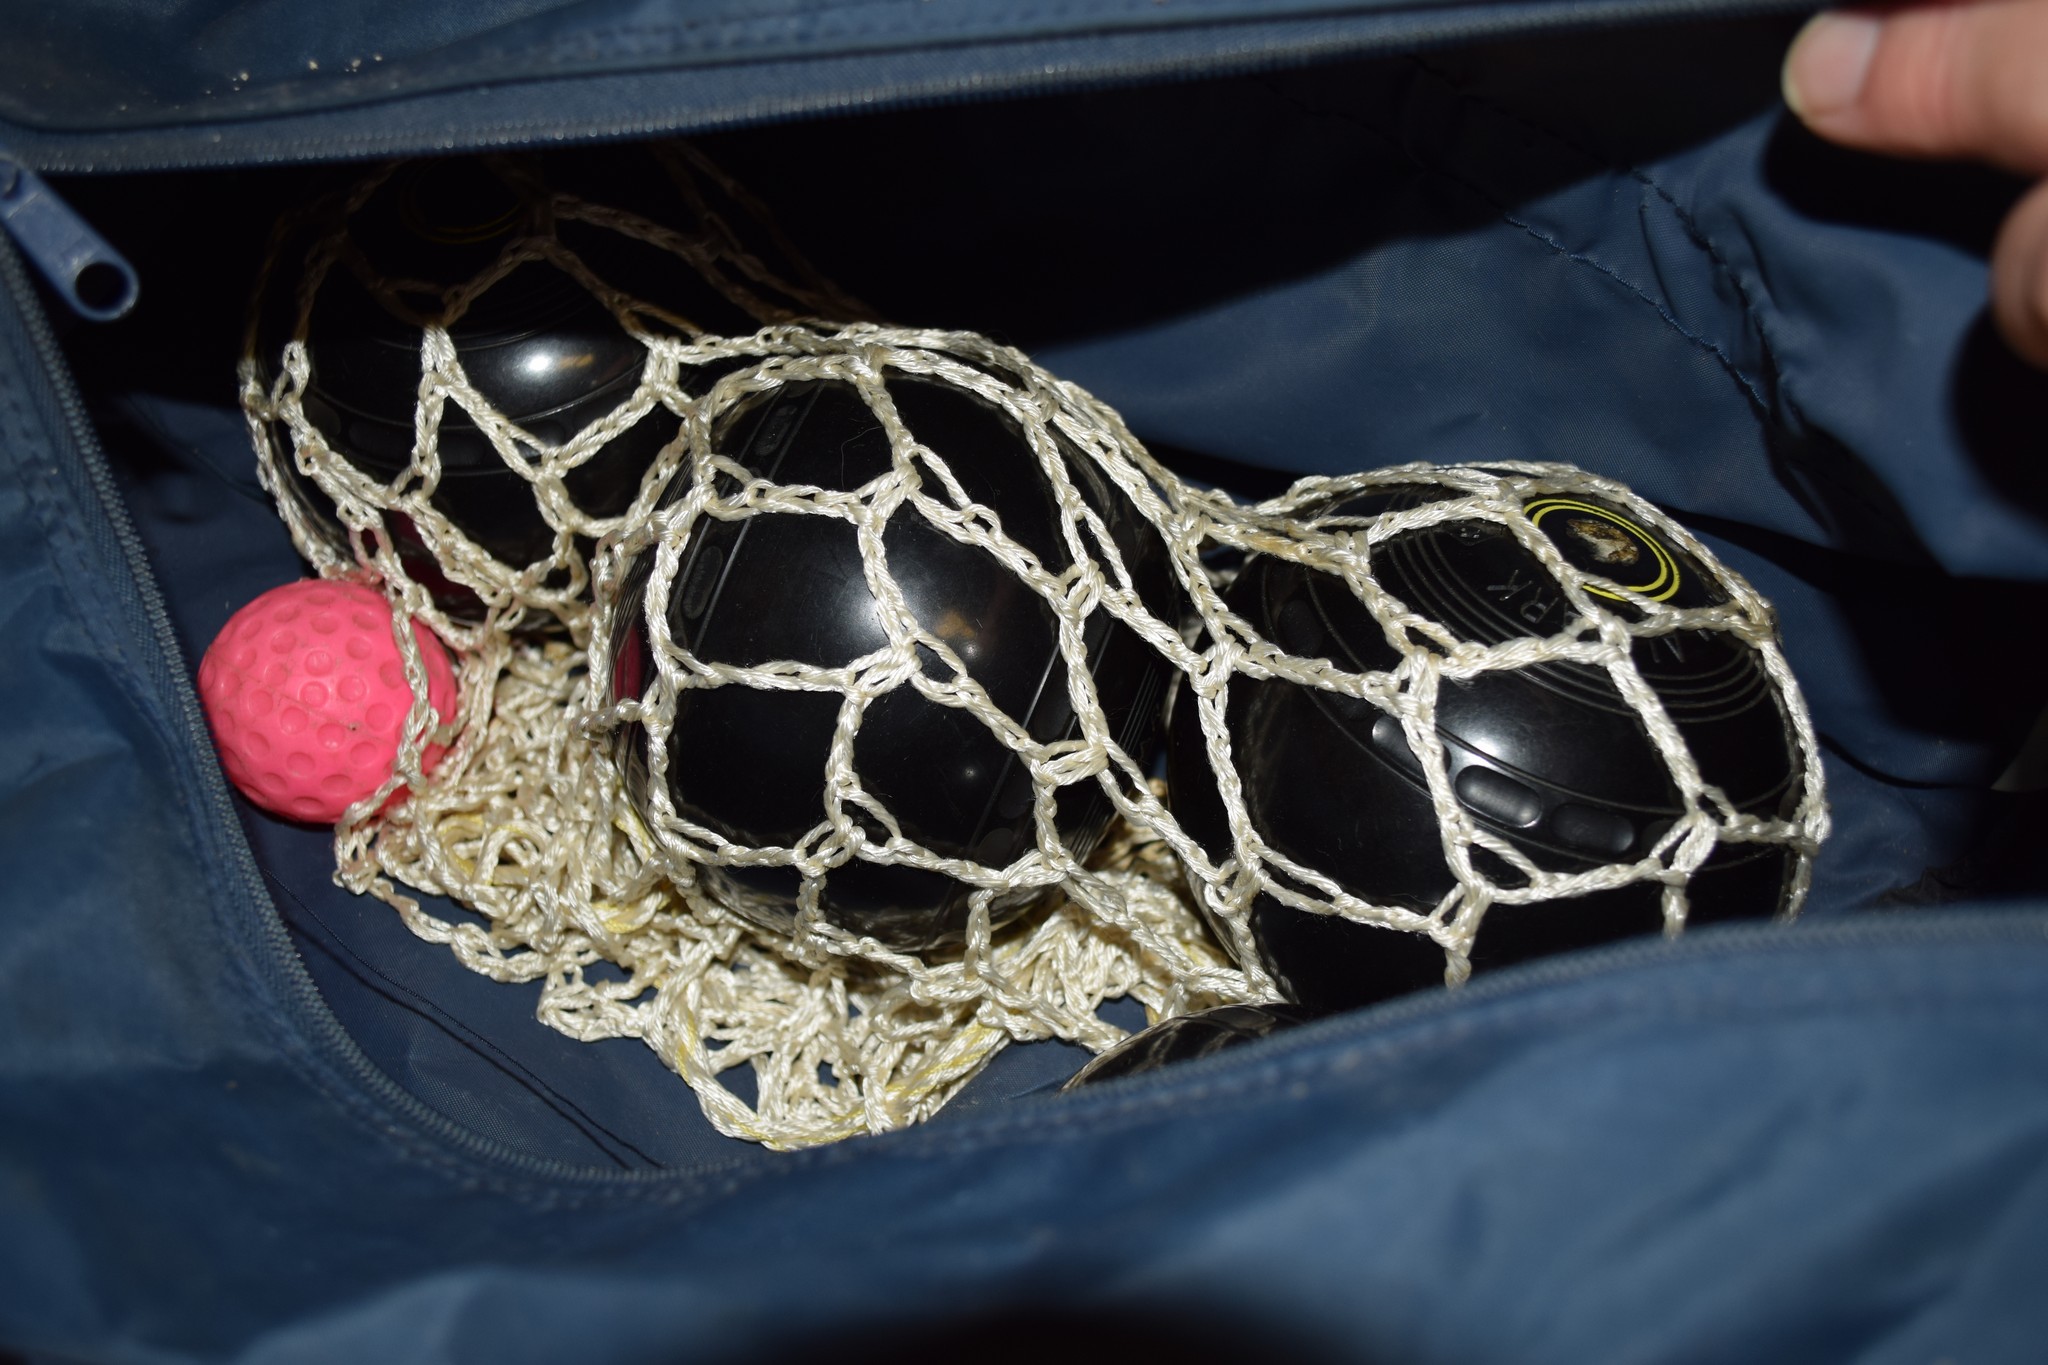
1784, 0, 2048, 176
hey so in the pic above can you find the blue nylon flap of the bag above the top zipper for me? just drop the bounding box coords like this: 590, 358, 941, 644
0, 0, 1798, 150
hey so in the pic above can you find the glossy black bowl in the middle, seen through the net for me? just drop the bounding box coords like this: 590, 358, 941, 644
612, 372, 1180, 950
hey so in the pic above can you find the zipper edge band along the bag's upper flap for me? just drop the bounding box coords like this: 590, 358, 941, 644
0, 0, 1815, 174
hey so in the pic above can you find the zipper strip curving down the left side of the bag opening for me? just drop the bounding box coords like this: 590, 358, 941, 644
0, 232, 766, 1185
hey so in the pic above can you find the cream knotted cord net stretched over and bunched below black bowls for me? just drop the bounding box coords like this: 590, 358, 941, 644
242, 149, 1827, 1148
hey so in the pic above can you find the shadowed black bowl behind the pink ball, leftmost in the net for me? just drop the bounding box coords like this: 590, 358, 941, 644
258, 160, 684, 620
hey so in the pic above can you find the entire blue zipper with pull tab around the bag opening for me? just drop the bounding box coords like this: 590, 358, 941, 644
0, 0, 1949, 1185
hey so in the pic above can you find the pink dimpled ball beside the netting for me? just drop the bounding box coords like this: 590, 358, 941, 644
199, 579, 455, 825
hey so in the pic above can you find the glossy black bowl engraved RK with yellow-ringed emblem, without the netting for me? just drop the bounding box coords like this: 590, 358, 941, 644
1169, 495, 1802, 1011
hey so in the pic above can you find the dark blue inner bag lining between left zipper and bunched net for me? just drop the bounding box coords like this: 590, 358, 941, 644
97, 397, 1114, 1171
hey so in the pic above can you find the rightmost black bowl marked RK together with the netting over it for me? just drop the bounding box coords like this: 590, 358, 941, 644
1169, 463, 1829, 1009
